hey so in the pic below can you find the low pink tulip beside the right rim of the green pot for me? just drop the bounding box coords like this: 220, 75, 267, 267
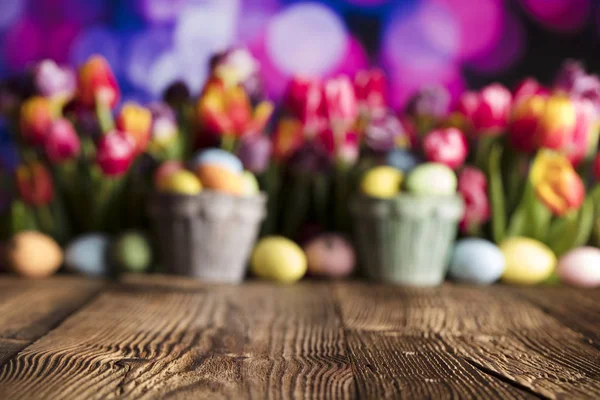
458, 167, 491, 234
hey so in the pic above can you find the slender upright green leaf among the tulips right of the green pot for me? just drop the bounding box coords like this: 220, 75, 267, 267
489, 144, 506, 243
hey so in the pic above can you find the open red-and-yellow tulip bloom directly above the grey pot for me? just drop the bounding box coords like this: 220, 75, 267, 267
196, 84, 273, 138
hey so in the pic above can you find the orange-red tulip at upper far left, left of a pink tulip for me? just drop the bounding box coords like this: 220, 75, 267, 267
20, 96, 54, 145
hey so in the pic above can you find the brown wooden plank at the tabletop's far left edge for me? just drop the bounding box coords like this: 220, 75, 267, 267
0, 276, 104, 364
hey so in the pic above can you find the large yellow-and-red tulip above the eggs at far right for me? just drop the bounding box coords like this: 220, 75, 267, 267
529, 150, 585, 216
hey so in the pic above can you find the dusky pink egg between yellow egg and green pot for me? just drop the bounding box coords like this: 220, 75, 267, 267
304, 233, 356, 278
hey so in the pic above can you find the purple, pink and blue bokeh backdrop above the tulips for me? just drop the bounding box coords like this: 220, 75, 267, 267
0, 0, 600, 107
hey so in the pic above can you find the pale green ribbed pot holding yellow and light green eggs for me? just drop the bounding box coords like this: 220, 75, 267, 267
350, 193, 464, 286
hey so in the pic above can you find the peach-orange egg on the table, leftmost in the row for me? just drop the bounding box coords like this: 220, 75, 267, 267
5, 231, 63, 278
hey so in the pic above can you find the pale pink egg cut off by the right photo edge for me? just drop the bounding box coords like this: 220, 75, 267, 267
556, 247, 600, 288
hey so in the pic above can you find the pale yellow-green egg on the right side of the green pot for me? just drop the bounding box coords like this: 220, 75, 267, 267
406, 163, 456, 196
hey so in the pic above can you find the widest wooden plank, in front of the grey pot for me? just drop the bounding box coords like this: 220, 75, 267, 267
0, 278, 355, 399
